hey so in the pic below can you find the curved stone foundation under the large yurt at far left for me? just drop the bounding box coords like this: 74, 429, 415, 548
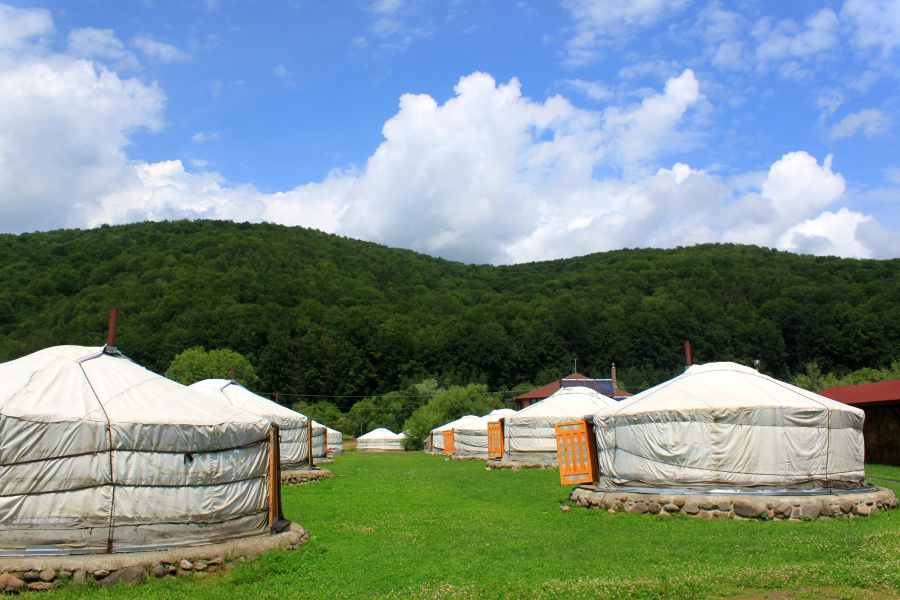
0, 521, 309, 592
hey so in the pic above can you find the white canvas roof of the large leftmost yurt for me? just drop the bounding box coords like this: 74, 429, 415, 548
0, 346, 268, 434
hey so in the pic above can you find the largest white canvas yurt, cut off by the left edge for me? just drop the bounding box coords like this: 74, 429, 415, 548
0, 346, 271, 556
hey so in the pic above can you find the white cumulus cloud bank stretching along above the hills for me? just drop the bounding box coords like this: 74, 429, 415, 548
0, 3, 900, 263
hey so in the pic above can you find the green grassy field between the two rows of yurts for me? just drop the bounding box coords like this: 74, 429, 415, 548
55, 452, 900, 600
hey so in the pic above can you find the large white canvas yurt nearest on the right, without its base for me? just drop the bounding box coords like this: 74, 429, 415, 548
594, 362, 867, 493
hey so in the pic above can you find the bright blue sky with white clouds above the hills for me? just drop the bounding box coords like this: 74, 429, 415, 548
0, 0, 900, 264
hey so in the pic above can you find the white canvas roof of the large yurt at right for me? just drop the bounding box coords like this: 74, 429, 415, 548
607, 362, 864, 428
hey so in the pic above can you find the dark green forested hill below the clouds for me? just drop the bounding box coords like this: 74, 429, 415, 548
0, 221, 900, 395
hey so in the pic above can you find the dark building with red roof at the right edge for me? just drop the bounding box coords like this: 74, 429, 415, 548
821, 381, 900, 465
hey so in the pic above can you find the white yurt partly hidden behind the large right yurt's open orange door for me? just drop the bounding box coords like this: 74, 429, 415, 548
503, 387, 618, 465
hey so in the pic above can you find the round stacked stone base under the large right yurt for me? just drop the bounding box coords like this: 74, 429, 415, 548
569, 486, 900, 521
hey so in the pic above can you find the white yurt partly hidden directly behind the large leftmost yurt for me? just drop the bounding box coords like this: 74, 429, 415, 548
188, 379, 309, 470
